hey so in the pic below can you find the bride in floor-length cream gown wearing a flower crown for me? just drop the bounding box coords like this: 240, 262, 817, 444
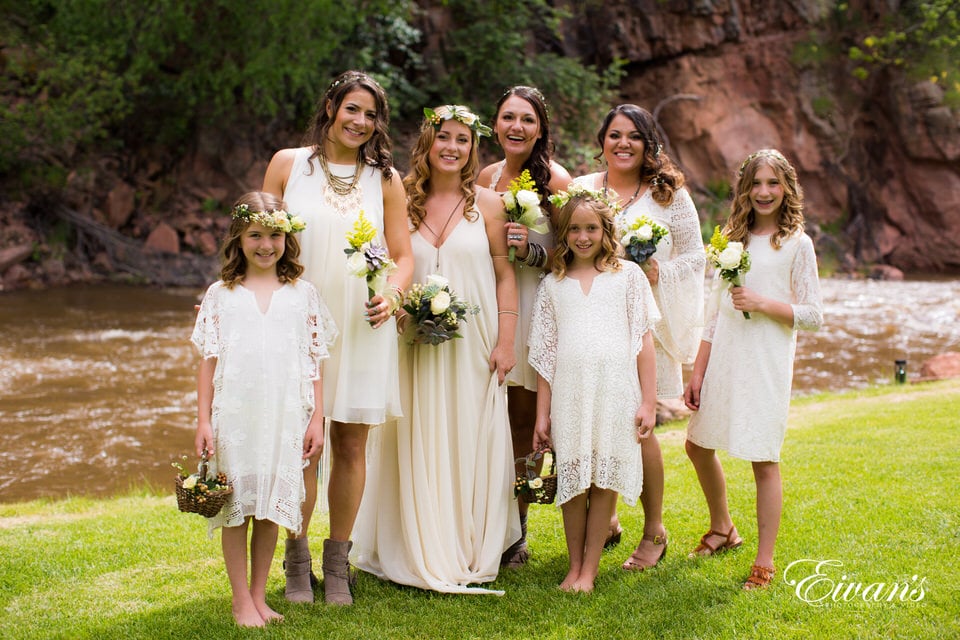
354, 105, 520, 594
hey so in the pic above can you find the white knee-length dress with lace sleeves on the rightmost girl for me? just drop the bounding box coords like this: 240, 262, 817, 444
687, 232, 823, 462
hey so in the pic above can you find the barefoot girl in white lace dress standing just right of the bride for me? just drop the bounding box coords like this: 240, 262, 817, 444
528, 186, 660, 591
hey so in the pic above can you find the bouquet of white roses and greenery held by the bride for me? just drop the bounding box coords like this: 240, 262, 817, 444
401, 274, 480, 345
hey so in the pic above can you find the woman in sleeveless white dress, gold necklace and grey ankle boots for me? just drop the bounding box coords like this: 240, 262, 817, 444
263, 71, 413, 604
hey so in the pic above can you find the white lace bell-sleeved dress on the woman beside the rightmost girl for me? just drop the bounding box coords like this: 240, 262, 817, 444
574, 173, 706, 400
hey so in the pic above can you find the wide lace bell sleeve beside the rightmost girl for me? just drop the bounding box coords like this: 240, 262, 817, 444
654, 189, 707, 363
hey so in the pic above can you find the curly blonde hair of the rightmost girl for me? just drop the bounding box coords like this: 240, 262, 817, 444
723, 149, 804, 249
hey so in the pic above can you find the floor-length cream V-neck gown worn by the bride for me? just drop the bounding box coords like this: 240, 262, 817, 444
352, 212, 520, 594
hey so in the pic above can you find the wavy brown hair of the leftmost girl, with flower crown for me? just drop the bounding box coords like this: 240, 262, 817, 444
220, 191, 303, 289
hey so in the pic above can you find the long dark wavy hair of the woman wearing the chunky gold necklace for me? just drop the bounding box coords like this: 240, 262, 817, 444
302, 71, 393, 178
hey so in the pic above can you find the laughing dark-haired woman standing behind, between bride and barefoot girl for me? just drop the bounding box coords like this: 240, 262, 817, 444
477, 85, 570, 568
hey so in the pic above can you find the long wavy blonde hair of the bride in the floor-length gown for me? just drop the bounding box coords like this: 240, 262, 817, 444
403, 110, 480, 229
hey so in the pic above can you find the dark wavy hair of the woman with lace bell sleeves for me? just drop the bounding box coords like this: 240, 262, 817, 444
594, 104, 686, 207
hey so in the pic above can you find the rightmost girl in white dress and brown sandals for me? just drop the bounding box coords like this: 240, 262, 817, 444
684, 149, 823, 590
